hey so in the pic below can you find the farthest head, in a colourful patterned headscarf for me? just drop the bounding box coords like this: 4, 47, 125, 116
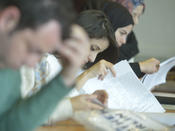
113, 0, 145, 24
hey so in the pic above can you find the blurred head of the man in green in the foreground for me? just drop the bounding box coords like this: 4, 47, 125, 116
0, 0, 75, 68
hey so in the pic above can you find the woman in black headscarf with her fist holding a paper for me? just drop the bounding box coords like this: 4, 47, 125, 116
84, 0, 160, 78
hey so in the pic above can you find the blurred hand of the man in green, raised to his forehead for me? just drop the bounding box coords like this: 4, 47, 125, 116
57, 25, 90, 86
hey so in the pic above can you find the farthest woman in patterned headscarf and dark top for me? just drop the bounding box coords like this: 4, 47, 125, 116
112, 0, 145, 60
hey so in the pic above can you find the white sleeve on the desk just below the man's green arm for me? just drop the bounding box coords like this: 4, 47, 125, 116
48, 98, 73, 124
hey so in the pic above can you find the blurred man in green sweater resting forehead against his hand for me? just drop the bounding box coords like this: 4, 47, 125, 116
0, 0, 88, 131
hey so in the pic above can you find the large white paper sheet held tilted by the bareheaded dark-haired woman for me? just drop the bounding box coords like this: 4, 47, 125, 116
82, 61, 164, 112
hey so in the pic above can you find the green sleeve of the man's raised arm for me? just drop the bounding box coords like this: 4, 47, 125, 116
0, 75, 71, 131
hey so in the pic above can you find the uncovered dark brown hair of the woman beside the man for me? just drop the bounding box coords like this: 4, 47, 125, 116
77, 10, 118, 68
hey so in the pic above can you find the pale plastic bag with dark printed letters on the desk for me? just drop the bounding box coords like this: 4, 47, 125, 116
73, 110, 174, 131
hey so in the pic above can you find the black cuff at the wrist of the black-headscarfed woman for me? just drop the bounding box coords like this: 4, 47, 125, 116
129, 62, 145, 78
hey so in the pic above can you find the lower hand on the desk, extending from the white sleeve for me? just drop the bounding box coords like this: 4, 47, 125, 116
71, 95, 103, 111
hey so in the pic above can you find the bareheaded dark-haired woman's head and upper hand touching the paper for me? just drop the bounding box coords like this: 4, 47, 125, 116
77, 10, 118, 88
